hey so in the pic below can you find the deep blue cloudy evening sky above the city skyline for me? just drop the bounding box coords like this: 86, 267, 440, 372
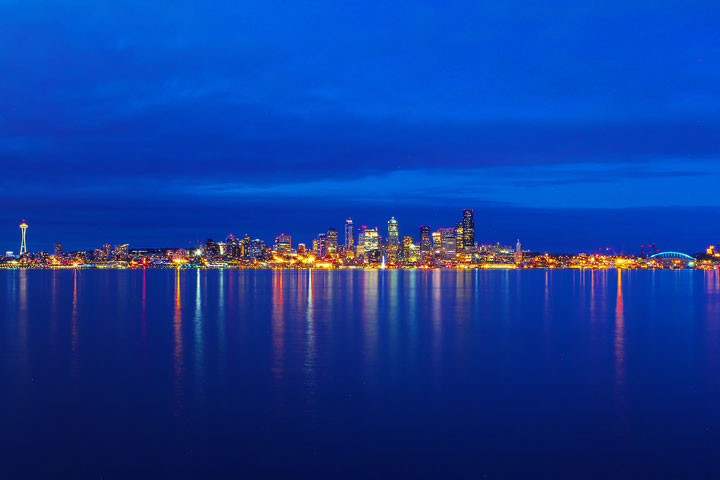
0, 0, 720, 253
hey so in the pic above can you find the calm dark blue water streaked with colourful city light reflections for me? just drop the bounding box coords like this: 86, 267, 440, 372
0, 270, 720, 479
